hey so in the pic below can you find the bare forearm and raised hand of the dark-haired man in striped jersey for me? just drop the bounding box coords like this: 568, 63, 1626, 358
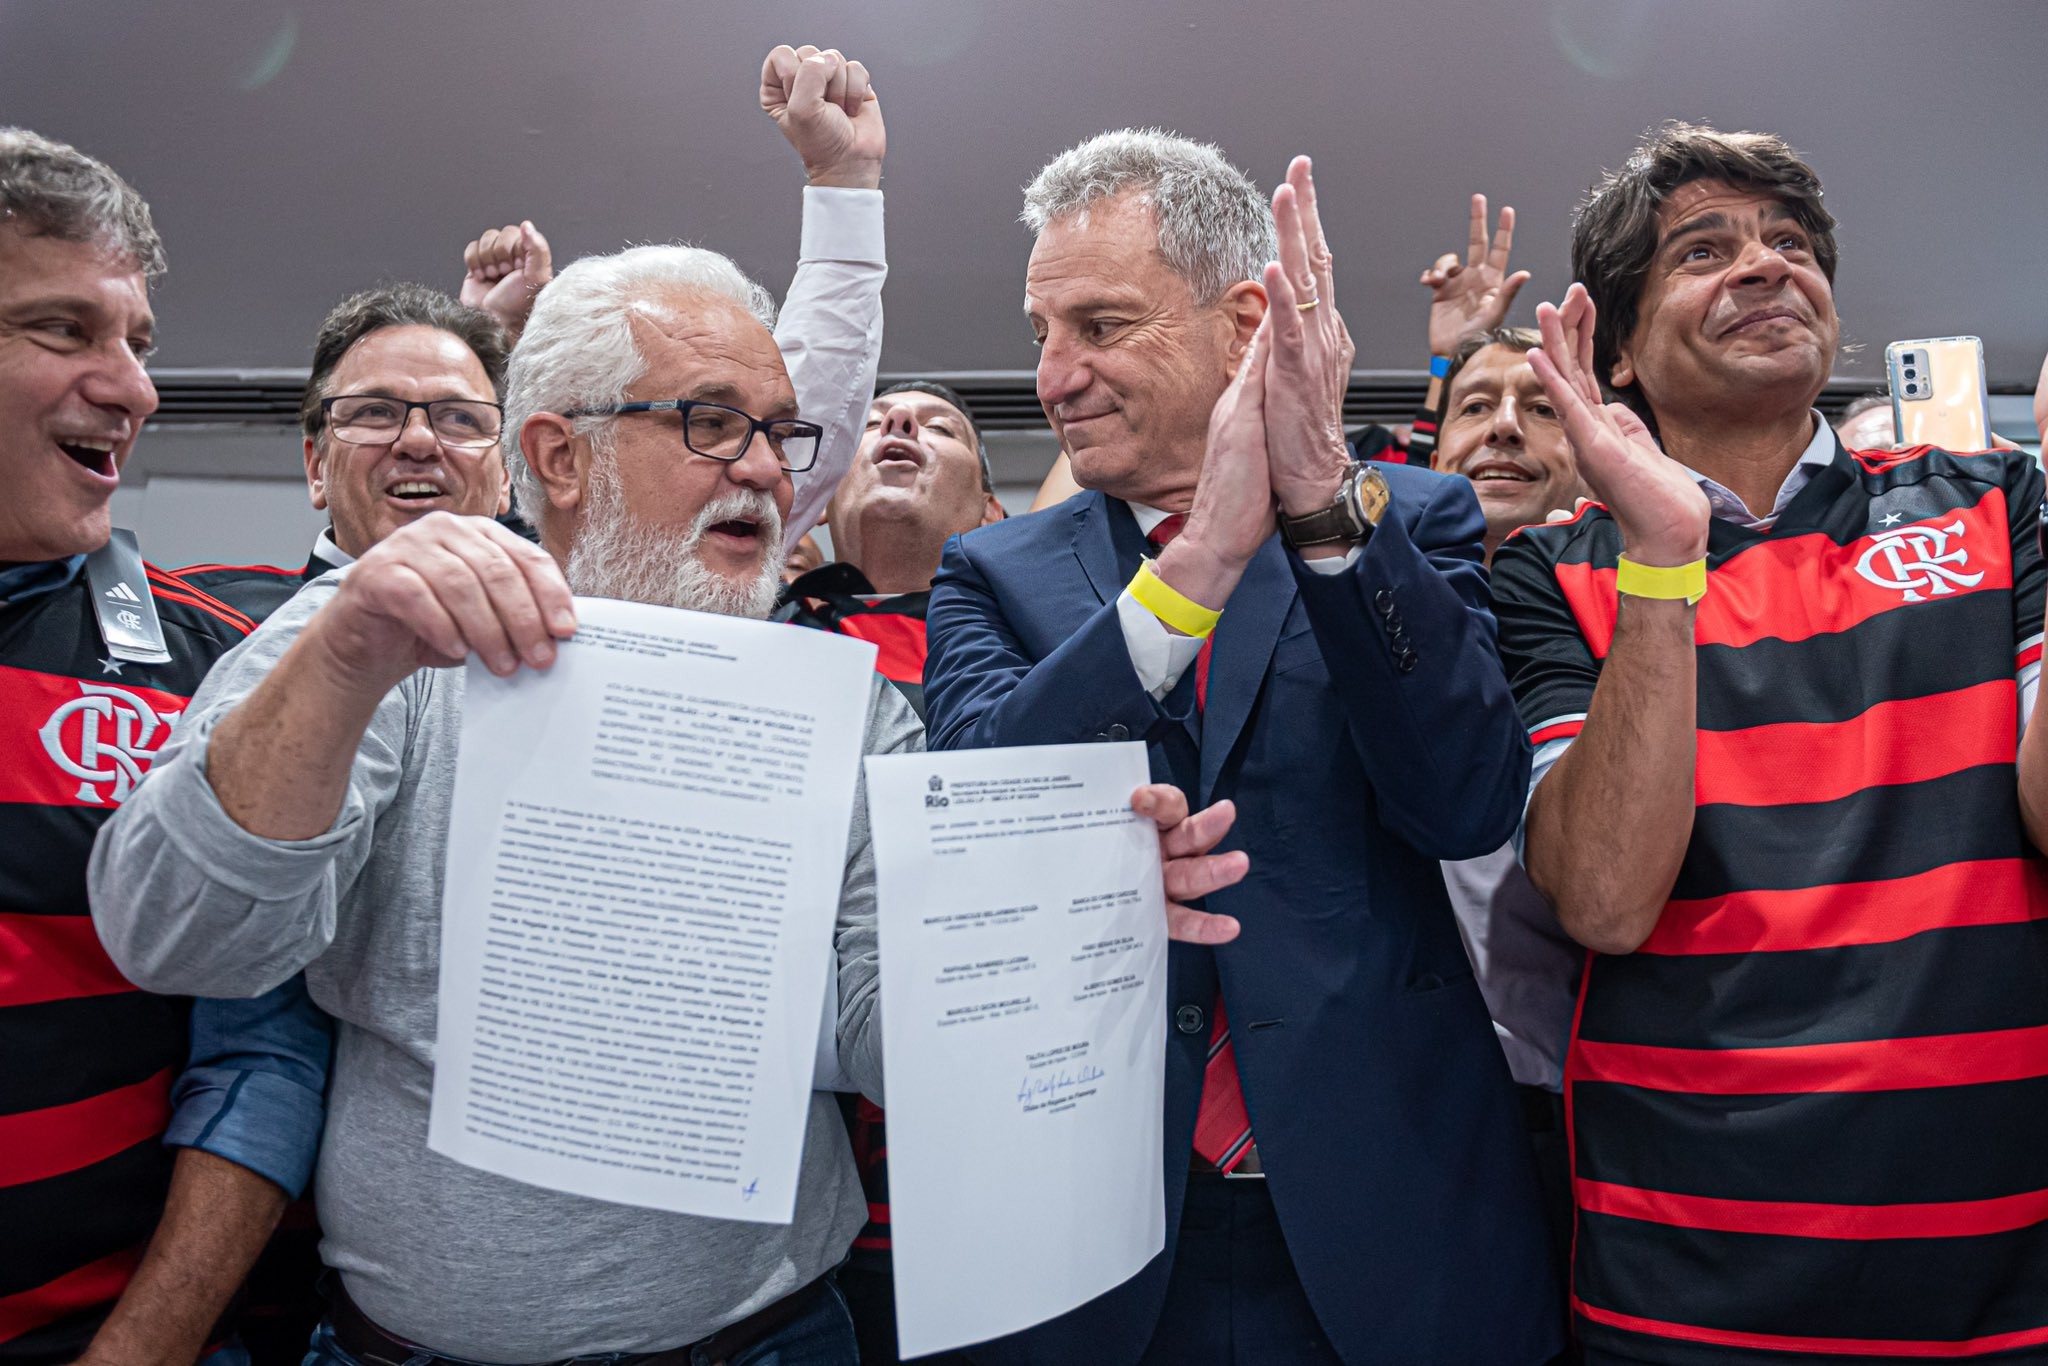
1524, 285, 1710, 952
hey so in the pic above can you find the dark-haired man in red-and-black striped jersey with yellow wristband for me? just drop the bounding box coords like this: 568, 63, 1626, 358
1493, 125, 2048, 1364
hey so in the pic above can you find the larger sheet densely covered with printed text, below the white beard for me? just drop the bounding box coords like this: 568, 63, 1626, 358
428, 598, 874, 1223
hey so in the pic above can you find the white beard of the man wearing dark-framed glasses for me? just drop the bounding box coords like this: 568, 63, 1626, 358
563, 457, 782, 621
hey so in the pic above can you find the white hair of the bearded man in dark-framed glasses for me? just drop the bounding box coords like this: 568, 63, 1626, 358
504, 246, 774, 526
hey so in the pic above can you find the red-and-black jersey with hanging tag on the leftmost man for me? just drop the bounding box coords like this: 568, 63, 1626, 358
0, 567, 252, 1362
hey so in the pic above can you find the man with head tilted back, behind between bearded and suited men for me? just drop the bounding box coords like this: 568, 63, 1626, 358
780, 379, 1004, 1366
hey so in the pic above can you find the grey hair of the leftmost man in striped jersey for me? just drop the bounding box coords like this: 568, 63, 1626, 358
0, 127, 168, 285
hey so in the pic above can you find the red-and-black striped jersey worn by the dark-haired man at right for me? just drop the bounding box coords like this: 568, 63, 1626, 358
1493, 444, 2048, 1362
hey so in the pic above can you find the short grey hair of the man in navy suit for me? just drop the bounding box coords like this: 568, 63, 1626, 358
1020, 129, 1280, 305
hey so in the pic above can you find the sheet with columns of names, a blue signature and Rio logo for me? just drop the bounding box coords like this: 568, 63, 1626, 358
866, 743, 1167, 1358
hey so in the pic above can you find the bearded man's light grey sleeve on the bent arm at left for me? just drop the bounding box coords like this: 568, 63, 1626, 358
88, 575, 422, 997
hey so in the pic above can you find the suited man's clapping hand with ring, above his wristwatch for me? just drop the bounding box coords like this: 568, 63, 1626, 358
1266, 156, 1356, 524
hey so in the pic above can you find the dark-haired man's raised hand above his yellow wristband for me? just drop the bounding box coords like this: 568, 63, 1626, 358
1530, 285, 1712, 567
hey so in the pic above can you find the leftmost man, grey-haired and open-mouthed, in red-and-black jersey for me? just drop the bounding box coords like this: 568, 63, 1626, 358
0, 129, 332, 1366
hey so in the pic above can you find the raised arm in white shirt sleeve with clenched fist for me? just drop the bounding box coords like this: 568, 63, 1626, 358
760, 45, 889, 545
